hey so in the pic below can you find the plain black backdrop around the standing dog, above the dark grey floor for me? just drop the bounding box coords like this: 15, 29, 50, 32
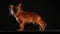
0, 0, 60, 30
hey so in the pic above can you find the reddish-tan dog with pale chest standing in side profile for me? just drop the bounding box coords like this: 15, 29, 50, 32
9, 3, 47, 31
